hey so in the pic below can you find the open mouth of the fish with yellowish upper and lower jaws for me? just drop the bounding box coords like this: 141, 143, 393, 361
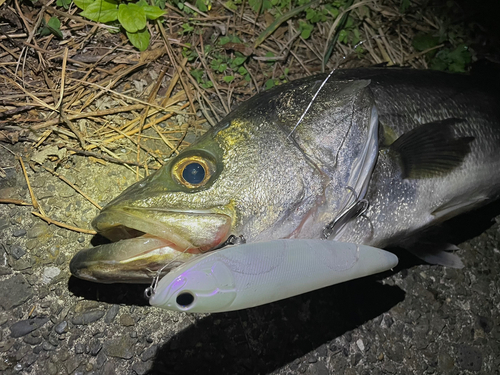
70, 207, 231, 283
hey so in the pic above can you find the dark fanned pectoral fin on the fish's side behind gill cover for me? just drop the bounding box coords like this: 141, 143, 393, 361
389, 118, 474, 178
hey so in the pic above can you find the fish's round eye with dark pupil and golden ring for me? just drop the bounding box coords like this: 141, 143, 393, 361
172, 155, 215, 188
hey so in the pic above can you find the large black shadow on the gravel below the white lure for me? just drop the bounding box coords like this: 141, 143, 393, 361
148, 273, 405, 375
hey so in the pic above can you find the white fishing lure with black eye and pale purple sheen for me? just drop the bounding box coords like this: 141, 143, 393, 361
149, 239, 398, 313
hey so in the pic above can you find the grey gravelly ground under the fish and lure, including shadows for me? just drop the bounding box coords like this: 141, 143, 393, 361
0, 144, 500, 375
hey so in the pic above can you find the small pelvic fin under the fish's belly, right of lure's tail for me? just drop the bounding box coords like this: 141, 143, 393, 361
407, 243, 464, 268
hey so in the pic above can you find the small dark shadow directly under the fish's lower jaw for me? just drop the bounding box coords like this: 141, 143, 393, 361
68, 276, 149, 306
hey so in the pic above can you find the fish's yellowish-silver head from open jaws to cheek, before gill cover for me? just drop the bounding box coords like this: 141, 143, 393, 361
70, 111, 325, 283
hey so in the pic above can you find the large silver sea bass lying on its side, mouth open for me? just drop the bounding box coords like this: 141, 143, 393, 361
70, 68, 500, 283
